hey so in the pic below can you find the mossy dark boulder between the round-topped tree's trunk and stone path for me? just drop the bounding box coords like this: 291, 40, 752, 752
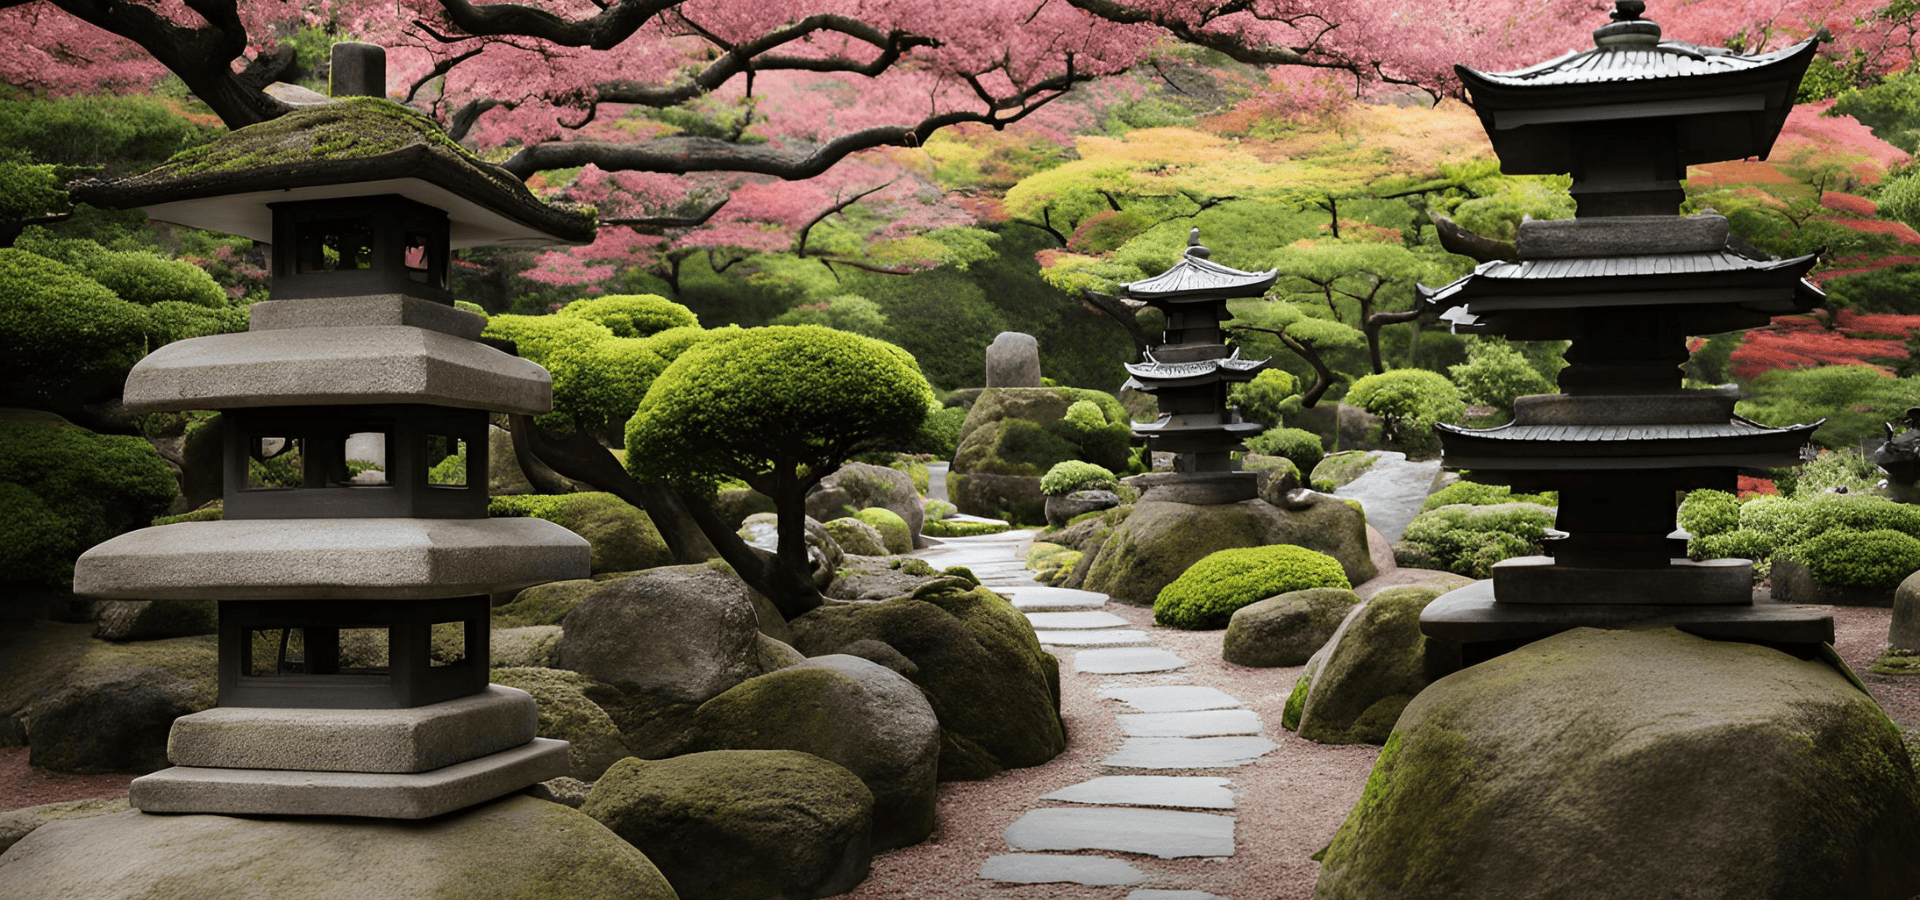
793, 578, 1066, 781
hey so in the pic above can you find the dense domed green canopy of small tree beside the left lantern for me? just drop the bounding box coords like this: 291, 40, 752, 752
626, 324, 933, 503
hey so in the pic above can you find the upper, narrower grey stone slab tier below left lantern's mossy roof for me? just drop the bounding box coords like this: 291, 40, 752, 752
123, 326, 553, 414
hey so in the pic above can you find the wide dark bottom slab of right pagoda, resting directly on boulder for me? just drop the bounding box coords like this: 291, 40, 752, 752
1421, 581, 1834, 679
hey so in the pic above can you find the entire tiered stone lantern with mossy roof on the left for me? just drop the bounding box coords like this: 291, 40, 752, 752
73, 44, 593, 819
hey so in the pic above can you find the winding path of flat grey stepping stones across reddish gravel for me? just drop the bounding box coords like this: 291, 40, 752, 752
914, 532, 1279, 900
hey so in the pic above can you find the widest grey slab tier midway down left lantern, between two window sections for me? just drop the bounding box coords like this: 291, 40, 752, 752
73, 514, 593, 601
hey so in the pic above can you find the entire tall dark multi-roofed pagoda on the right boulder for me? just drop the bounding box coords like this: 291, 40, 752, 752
1421, 0, 1834, 674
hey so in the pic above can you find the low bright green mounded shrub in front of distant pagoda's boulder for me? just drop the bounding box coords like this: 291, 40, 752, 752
1154, 543, 1352, 629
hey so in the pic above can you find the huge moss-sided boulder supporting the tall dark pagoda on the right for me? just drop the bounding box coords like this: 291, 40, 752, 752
1313, 628, 1920, 900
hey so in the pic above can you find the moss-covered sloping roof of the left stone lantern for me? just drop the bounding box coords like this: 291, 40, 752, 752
69, 98, 595, 248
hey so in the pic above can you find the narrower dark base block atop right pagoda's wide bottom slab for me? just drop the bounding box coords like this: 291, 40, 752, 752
1492, 557, 1753, 606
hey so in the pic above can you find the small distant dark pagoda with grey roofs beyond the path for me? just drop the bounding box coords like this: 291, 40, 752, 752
1119, 228, 1277, 505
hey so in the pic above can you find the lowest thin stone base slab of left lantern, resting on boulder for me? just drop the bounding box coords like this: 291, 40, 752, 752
129, 737, 566, 819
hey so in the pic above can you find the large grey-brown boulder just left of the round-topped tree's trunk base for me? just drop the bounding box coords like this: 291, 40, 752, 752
559, 564, 783, 758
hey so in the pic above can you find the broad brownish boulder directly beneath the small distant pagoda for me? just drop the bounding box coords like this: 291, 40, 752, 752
1069, 493, 1375, 606
